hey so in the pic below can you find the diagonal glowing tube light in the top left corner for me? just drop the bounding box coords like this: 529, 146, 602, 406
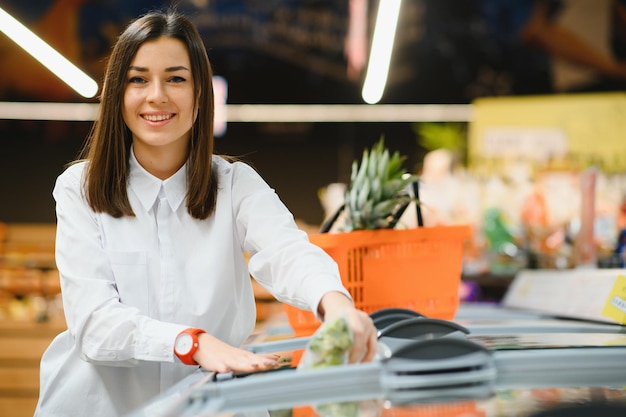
0, 8, 98, 98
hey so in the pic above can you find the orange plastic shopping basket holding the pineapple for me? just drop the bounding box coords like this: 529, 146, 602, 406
284, 226, 470, 336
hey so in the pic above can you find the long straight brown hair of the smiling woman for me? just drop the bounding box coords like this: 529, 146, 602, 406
80, 10, 217, 219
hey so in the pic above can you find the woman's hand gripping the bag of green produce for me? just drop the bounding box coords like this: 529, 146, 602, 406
319, 292, 378, 363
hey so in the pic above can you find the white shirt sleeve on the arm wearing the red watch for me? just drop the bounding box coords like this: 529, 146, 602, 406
53, 164, 187, 366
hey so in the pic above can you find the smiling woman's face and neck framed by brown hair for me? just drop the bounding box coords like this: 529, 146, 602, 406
122, 36, 197, 176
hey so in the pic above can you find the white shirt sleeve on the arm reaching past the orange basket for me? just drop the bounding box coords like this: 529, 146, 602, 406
229, 162, 351, 314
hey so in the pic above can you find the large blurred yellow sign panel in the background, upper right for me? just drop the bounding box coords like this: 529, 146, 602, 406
468, 93, 626, 172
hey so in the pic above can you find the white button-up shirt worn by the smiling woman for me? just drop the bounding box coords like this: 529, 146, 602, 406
36, 152, 348, 417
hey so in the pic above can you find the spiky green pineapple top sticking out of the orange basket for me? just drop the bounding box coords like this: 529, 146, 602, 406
343, 137, 418, 231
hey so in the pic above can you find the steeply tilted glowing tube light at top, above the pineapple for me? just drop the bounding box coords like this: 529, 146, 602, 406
361, 0, 401, 104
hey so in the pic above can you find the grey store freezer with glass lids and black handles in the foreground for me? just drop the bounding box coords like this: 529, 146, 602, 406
131, 309, 626, 417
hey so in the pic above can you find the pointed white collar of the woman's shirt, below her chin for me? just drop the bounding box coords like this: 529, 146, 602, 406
129, 147, 187, 211
